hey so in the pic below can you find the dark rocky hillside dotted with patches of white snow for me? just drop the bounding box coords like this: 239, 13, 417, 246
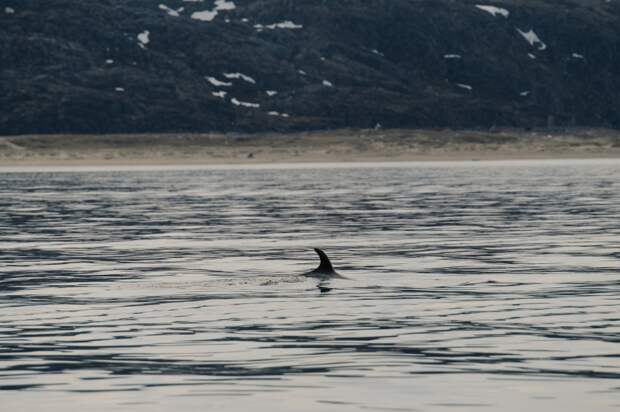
0, 0, 620, 135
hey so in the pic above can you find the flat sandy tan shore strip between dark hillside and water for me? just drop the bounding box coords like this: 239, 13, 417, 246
0, 129, 620, 167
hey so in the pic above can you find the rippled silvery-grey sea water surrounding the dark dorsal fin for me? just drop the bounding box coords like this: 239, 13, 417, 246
0, 160, 620, 412
